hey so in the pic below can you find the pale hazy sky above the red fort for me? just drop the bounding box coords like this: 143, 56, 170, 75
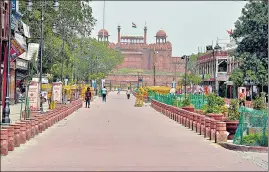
89, 1, 246, 56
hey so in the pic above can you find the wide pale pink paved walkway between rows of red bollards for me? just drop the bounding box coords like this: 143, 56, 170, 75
1, 93, 268, 171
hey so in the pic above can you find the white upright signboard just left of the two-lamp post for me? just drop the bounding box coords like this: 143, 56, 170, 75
28, 81, 40, 111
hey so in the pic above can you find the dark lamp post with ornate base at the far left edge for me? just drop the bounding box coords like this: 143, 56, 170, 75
2, 1, 12, 124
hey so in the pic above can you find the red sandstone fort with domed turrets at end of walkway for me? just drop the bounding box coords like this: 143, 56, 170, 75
97, 26, 184, 85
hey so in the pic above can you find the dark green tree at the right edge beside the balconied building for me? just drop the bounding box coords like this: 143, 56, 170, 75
231, 1, 268, 86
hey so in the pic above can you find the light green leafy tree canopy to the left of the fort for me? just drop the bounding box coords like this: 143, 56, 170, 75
20, 0, 123, 82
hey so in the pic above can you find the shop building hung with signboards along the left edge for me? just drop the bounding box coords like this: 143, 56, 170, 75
0, 0, 30, 105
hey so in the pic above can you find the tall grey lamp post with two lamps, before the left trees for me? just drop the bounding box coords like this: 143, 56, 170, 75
26, 0, 59, 112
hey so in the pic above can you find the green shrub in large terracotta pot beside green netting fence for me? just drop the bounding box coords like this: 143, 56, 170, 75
225, 99, 240, 140
